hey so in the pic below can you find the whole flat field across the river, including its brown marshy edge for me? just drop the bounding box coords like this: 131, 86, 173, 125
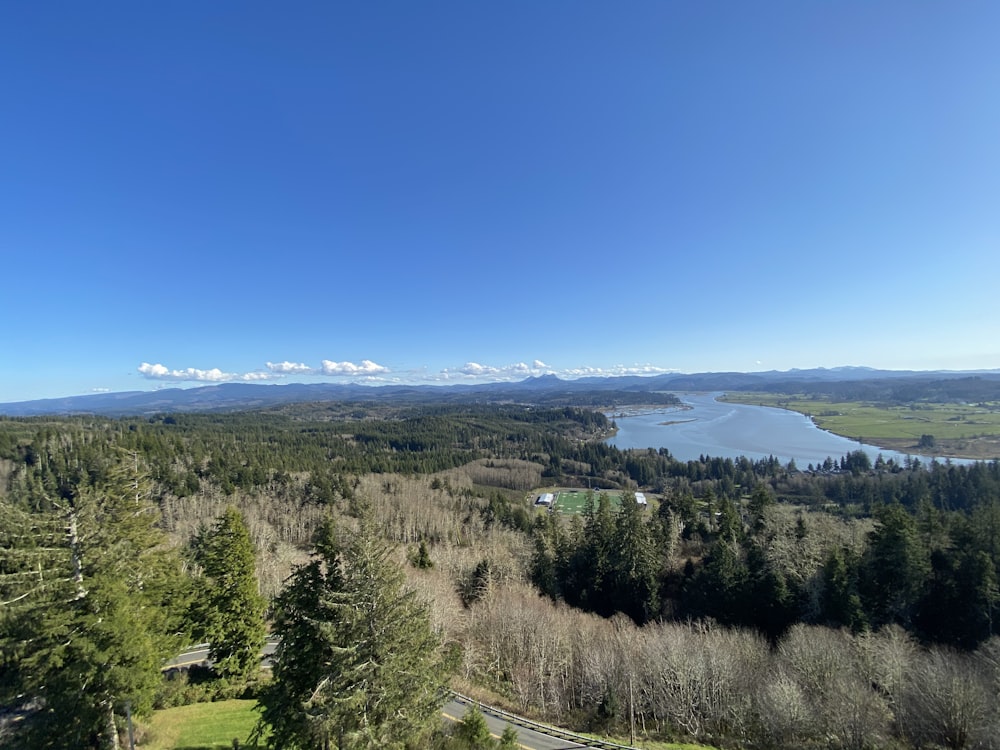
724, 393, 1000, 458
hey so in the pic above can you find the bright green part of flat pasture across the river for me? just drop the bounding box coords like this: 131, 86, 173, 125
725, 393, 1000, 441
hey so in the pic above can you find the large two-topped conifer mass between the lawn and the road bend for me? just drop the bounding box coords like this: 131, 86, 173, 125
260, 511, 446, 750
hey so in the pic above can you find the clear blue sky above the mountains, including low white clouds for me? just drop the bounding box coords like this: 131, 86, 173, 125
0, 0, 1000, 401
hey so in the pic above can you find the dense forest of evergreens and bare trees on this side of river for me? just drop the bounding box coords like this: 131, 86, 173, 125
0, 403, 1000, 748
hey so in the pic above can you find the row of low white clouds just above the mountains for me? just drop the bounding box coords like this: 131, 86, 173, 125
136, 359, 677, 385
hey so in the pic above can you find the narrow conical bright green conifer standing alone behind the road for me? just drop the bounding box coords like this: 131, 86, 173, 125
194, 507, 267, 682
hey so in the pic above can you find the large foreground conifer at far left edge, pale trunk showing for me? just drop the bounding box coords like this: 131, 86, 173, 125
3, 462, 183, 748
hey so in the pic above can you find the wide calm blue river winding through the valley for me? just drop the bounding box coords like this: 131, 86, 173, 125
608, 393, 948, 469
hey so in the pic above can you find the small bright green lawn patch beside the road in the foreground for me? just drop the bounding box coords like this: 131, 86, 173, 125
141, 700, 258, 750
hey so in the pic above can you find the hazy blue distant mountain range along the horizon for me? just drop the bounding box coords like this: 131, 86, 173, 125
0, 367, 1000, 416
